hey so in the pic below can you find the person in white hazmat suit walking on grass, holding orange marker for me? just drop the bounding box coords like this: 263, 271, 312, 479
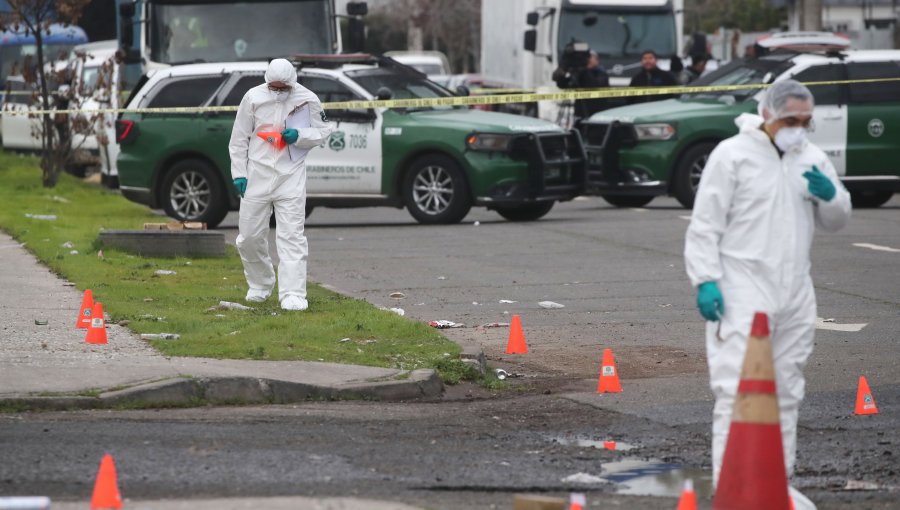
228, 59, 332, 310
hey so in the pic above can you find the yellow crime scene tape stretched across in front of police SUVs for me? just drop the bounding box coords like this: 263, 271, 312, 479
3, 78, 900, 115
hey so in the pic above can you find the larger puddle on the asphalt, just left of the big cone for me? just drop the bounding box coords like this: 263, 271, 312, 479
600, 459, 712, 499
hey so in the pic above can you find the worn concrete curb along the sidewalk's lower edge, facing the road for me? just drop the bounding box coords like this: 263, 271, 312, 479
0, 369, 444, 411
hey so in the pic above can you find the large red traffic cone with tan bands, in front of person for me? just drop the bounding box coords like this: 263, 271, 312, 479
713, 312, 791, 510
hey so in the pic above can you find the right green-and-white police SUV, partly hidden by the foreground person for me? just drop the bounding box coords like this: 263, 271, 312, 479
584, 49, 900, 208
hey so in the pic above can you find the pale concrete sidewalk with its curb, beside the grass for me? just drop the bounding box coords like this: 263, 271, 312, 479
0, 233, 443, 409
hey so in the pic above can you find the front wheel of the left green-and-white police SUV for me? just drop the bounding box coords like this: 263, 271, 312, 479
403, 154, 472, 225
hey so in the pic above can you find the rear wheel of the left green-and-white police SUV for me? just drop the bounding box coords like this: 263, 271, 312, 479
160, 159, 228, 228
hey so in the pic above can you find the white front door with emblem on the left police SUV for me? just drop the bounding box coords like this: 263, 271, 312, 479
299, 75, 382, 196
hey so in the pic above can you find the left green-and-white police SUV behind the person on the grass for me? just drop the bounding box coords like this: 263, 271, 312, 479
116, 56, 585, 225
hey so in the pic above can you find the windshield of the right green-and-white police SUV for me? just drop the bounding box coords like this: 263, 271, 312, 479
681, 55, 793, 101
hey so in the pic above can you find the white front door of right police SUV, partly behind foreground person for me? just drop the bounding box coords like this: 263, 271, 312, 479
793, 63, 848, 175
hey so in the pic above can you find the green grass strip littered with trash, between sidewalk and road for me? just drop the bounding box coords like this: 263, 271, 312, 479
0, 153, 463, 374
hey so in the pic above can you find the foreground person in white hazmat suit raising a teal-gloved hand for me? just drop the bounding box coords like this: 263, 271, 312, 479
684, 80, 850, 510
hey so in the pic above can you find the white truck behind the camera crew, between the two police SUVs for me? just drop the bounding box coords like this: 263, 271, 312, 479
481, 0, 684, 121
